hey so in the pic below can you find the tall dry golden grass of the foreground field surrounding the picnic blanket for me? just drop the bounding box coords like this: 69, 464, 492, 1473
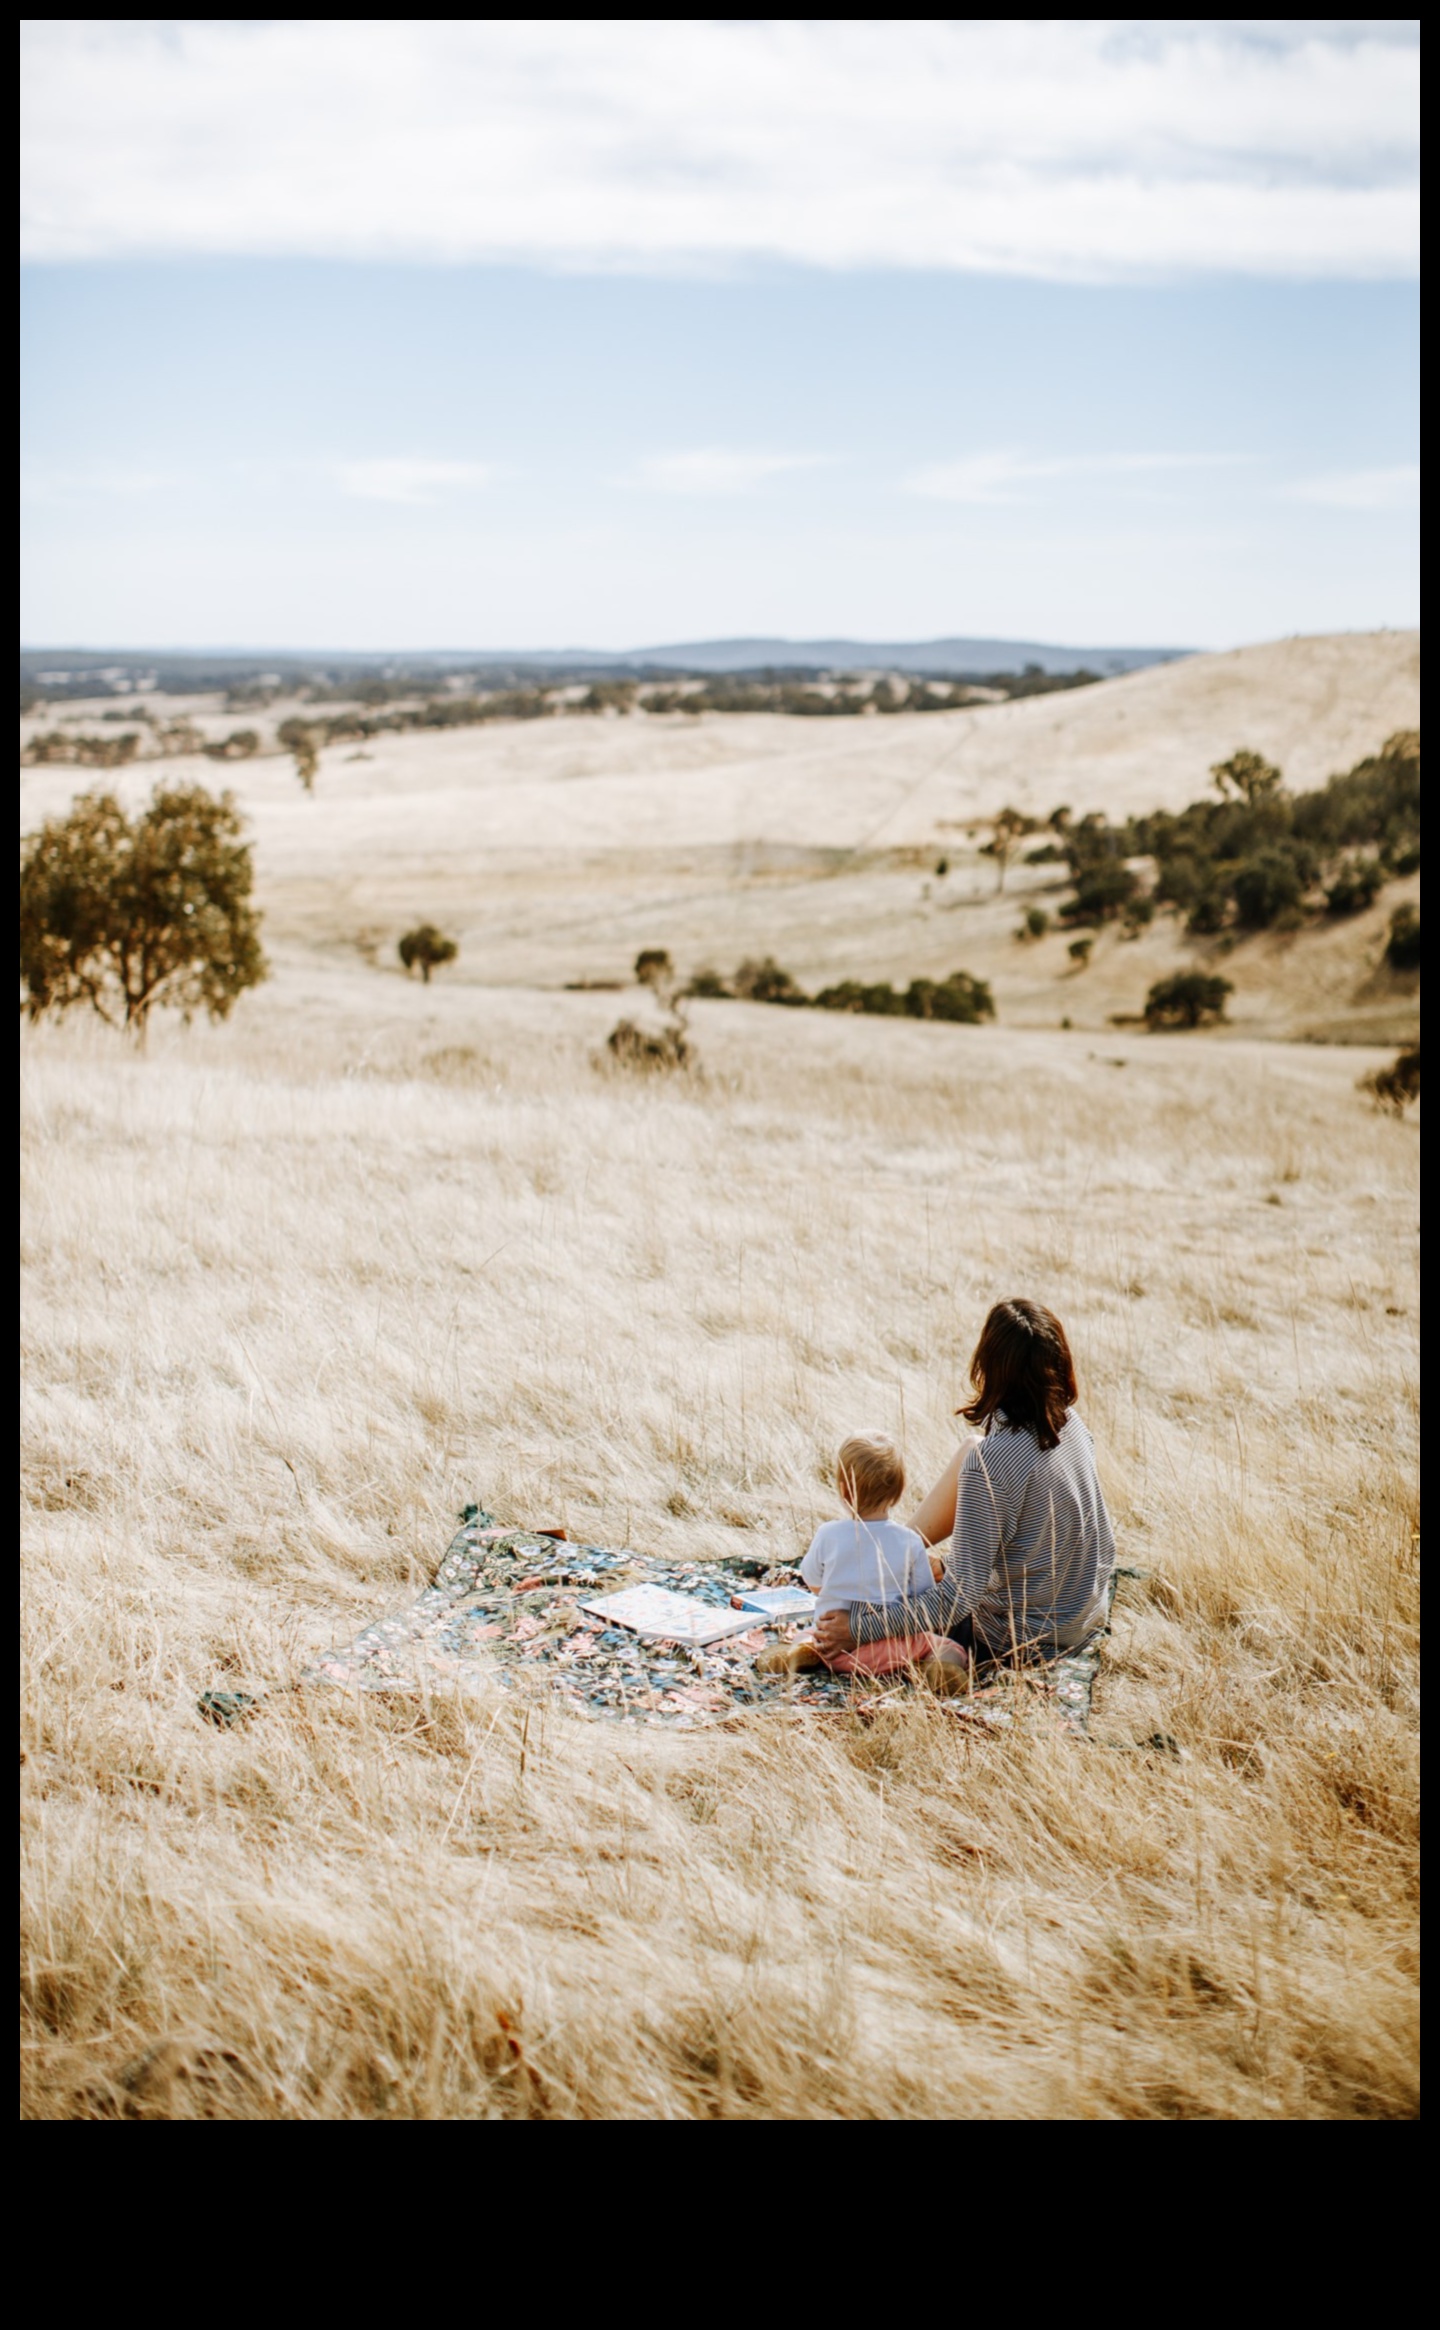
21, 969, 1417, 2118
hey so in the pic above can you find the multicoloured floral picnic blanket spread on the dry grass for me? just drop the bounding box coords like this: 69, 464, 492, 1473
301, 1505, 1100, 1731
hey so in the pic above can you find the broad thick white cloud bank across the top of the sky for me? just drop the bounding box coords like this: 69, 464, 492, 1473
23, 19, 1419, 280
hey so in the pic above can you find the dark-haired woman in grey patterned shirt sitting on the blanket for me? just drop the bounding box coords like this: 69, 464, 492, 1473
816, 1300, 1116, 1659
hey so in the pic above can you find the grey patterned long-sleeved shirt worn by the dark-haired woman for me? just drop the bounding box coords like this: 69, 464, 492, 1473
850, 1407, 1116, 1652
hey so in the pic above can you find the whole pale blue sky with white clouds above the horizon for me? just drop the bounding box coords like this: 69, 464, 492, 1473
21, 23, 1419, 648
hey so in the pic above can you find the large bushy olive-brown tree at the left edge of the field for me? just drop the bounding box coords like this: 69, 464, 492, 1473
21, 785, 266, 1042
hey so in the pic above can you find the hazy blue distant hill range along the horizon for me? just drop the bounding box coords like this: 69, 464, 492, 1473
21, 638, 1191, 697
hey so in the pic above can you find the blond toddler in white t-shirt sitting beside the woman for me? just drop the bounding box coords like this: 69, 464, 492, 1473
755, 1433, 965, 1680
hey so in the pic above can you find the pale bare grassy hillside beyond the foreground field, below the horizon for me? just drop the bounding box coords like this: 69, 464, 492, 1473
21, 634, 1419, 1044
